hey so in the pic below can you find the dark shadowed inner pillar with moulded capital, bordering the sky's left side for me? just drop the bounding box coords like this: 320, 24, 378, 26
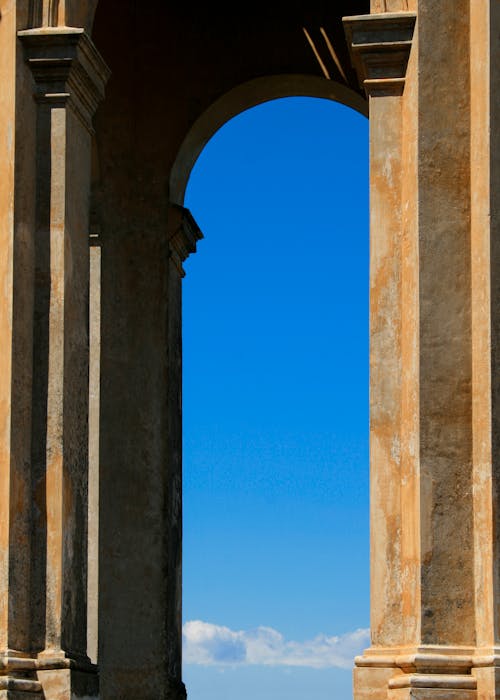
98, 194, 201, 700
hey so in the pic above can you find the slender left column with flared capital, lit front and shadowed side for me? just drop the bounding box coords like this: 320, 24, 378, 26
18, 27, 108, 700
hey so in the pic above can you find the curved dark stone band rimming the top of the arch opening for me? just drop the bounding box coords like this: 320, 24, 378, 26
170, 74, 368, 205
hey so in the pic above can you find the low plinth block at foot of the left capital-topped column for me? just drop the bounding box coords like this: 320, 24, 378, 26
37, 668, 99, 700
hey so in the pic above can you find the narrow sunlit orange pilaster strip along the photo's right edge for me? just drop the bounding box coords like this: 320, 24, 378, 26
470, 0, 500, 700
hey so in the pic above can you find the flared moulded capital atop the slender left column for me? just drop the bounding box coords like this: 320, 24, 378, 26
18, 27, 111, 131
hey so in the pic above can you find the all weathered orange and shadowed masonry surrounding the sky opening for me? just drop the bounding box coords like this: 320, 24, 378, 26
0, 0, 500, 700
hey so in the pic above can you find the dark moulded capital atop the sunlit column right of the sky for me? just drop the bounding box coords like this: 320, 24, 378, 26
343, 12, 416, 97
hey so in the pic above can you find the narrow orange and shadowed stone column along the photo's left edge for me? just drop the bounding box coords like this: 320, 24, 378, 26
0, 3, 41, 700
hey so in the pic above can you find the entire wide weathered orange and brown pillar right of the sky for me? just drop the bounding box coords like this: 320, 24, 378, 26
346, 0, 499, 700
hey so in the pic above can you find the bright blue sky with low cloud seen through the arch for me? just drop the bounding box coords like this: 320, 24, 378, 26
183, 98, 369, 700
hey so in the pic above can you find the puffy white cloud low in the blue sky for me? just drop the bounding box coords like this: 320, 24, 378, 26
182, 620, 370, 668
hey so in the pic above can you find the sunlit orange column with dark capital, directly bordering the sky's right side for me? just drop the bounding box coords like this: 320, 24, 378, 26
344, 13, 418, 700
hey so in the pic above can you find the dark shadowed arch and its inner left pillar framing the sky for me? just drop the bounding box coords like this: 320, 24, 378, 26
88, 4, 374, 697
